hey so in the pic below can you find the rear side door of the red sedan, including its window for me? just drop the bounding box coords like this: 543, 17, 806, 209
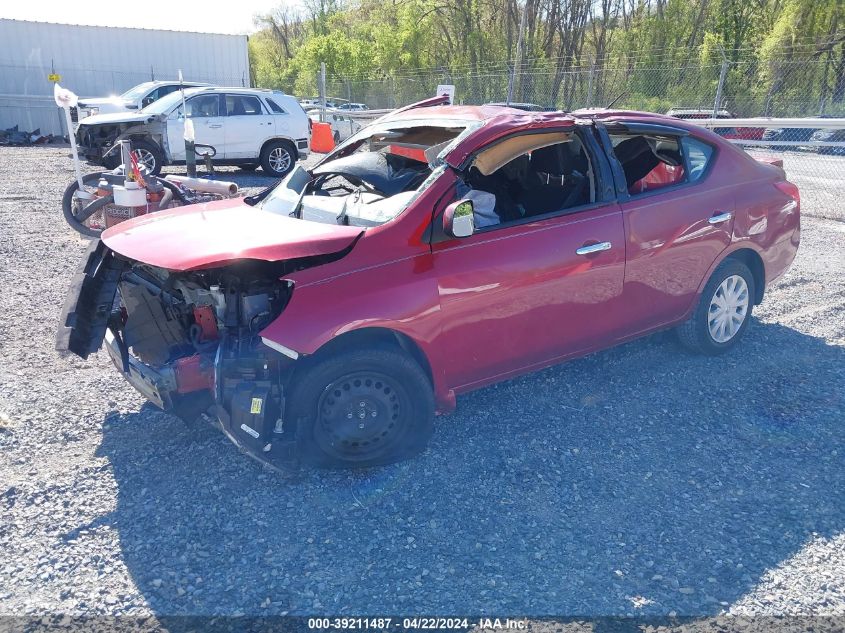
608, 122, 734, 333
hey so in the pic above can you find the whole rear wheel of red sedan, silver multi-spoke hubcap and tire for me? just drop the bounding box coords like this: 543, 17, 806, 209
677, 259, 755, 356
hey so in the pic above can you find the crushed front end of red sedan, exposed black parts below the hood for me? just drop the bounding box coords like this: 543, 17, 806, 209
56, 241, 297, 469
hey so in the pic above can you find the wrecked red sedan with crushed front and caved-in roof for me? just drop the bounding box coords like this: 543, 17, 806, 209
58, 97, 800, 467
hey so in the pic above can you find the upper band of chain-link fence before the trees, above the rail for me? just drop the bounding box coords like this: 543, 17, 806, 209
314, 60, 845, 117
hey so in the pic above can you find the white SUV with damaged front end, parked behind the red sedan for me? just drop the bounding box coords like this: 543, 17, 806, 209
76, 88, 310, 177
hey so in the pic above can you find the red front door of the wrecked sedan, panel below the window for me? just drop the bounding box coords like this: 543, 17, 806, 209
432, 130, 625, 390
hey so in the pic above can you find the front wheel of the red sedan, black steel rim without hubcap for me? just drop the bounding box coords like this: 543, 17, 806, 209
287, 348, 434, 468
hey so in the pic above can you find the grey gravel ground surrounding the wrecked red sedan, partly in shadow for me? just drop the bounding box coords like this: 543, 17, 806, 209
0, 147, 845, 618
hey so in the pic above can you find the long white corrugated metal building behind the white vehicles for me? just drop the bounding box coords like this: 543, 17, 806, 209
0, 19, 250, 134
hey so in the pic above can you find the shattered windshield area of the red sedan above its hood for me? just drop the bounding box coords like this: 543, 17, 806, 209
260, 119, 480, 226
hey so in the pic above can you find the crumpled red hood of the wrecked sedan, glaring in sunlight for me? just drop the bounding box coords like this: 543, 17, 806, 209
102, 198, 363, 271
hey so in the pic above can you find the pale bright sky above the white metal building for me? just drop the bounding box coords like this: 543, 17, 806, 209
0, 0, 286, 34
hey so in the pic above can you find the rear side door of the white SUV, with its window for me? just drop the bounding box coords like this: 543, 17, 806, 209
223, 93, 278, 160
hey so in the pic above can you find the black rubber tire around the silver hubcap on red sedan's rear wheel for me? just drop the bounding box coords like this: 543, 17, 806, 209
676, 259, 756, 356
